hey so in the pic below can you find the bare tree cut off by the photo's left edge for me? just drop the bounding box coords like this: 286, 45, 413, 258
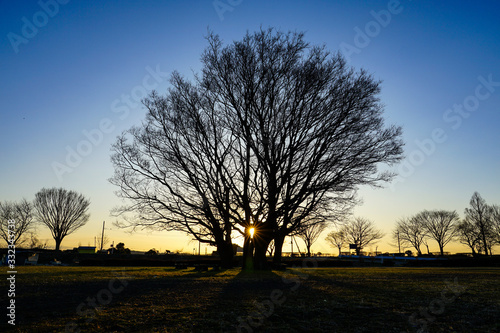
0, 199, 35, 246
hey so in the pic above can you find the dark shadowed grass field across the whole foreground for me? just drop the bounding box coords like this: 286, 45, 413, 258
0, 263, 500, 333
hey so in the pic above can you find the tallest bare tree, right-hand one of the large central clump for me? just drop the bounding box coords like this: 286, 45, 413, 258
202, 29, 402, 266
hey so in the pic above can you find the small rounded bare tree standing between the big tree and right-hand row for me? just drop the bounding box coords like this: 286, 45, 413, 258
342, 217, 384, 255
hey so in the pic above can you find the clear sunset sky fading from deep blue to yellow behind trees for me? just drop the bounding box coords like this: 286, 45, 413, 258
0, 0, 500, 253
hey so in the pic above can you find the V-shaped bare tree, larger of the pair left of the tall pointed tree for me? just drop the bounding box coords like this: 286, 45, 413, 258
413, 210, 460, 255
